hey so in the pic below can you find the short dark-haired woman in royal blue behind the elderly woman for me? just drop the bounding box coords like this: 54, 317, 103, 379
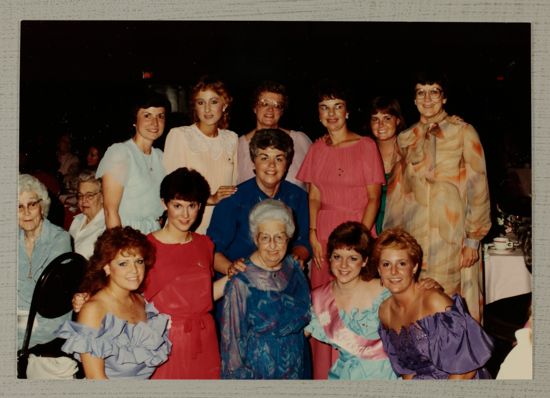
207, 129, 310, 274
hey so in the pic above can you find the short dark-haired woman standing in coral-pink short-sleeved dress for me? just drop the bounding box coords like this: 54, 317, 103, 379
297, 81, 385, 379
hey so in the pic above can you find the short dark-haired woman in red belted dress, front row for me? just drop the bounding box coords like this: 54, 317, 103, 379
144, 168, 231, 379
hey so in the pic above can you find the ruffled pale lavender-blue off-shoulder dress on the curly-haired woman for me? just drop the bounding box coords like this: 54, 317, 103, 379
56, 302, 172, 379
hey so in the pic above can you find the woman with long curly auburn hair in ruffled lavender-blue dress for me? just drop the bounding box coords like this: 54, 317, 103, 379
56, 227, 171, 379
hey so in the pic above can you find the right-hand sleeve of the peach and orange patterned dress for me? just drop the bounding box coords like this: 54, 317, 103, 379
463, 124, 491, 240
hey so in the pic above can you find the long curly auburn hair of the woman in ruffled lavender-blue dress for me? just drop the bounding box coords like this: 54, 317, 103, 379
79, 227, 156, 295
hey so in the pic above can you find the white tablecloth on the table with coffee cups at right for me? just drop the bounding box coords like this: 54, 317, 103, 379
483, 245, 531, 304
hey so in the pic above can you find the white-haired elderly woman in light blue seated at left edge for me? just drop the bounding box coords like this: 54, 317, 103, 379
17, 174, 71, 377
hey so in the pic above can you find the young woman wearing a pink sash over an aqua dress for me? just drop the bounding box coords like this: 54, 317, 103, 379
305, 221, 397, 380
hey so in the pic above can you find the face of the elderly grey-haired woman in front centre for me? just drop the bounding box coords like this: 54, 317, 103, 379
254, 220, 288, 268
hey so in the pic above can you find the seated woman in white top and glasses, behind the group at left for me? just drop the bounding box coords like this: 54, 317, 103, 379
69, 170, 105, 259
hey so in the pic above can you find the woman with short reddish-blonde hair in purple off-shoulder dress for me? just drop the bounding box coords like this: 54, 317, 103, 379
371, 228, 493, 379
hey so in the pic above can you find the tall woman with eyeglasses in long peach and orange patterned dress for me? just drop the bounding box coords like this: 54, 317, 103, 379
384, 72, 491, 320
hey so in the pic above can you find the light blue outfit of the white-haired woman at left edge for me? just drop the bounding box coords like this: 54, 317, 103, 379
17, 219, 72, 348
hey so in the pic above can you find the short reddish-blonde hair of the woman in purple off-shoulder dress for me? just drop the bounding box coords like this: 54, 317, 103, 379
370, 228, 422, 281
